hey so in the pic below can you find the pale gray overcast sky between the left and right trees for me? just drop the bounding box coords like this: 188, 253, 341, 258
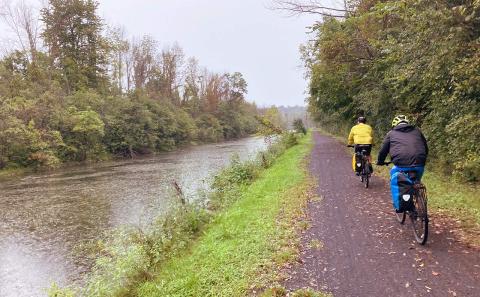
99, 0, 317, 106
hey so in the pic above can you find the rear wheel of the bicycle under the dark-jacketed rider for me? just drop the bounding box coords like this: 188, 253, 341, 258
410, 184, 428, 245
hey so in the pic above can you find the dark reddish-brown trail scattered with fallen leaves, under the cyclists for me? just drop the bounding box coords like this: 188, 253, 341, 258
285, 133, 480, 297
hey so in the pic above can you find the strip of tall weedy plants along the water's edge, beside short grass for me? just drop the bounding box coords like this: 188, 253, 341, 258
48, 133, 297, 297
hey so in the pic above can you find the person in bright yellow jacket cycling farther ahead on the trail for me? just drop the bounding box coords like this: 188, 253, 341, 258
348, 117, 373, 175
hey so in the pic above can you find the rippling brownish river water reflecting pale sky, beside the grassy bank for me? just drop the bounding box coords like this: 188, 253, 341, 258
0, 137, 265, 297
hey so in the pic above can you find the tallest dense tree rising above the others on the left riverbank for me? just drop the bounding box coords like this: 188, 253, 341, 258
41, 0, 108, 92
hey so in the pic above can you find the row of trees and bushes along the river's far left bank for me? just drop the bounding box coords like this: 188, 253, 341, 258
0, 0, 257, 169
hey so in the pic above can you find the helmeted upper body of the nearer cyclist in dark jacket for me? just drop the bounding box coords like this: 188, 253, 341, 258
377, 115, 428, 180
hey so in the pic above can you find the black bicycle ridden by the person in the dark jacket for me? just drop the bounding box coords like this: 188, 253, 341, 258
385, 162, 429, 245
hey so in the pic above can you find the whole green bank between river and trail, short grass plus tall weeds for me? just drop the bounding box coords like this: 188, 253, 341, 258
49, 134, 311, 297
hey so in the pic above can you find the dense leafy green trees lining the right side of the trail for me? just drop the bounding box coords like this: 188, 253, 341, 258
302, 0, 480, 181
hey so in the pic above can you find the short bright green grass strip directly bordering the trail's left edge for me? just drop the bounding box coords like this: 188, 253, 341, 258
137, 136, 311, 297
